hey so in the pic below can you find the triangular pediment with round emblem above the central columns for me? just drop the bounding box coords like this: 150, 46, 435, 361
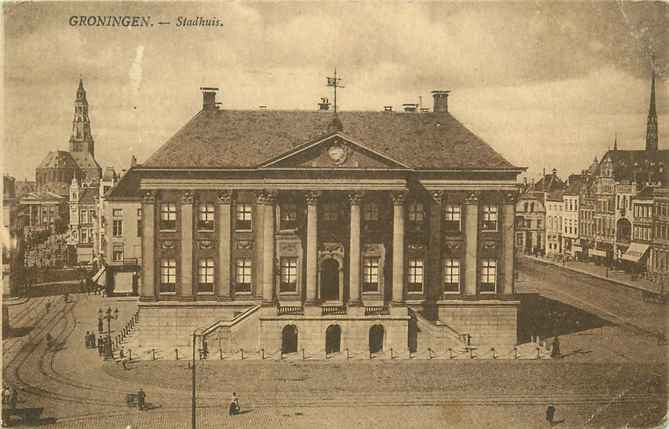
260, 132, 409, 170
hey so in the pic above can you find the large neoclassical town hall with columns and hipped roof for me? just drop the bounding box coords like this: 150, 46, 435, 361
128, 88, 522, 358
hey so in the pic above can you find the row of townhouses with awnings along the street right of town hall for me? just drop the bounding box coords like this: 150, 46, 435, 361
516, 77, 669, 278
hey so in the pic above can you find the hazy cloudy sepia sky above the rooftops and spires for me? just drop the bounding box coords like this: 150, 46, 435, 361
1, 1, 669, 180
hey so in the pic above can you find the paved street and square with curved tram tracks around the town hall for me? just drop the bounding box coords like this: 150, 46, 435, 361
3, 261, 667, 429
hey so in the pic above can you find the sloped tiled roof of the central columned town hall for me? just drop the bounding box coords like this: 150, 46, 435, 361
143, 109, 518, 169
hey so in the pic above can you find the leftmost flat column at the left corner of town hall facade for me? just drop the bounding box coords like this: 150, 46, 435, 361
140, 191, 156, 301
